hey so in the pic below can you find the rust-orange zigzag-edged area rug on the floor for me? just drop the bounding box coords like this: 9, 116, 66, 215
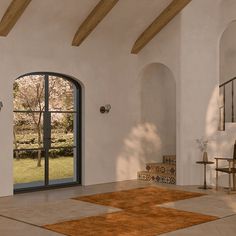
44, 187, 217, 236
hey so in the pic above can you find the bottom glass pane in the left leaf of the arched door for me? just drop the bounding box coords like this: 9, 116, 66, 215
13, 150, 44, 189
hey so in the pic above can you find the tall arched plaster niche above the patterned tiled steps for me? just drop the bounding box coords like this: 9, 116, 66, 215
140, 63, 176, 162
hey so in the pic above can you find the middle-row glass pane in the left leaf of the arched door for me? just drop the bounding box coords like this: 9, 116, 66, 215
13, 112, 43, 149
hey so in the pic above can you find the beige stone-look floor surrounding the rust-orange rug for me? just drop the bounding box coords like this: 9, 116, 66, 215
0, 180, 236, 236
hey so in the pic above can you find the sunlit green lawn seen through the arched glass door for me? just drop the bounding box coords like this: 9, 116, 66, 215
14, 157, 74, 184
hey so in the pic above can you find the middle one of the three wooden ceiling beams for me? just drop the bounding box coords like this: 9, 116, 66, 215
72, 0, 119, 46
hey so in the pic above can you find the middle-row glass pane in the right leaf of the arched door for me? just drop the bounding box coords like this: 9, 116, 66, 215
51, 113, 76, 148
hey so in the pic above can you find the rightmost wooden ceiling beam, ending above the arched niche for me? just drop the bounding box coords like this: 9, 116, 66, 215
131, 0, 191, 54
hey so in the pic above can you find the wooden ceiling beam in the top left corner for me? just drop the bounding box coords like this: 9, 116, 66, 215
0, 0, 31, 36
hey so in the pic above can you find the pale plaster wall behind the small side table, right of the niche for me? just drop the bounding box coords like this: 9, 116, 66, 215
178, 0, 236, 184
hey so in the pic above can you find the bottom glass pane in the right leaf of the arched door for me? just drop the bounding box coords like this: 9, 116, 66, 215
49, 148, 76, 184
